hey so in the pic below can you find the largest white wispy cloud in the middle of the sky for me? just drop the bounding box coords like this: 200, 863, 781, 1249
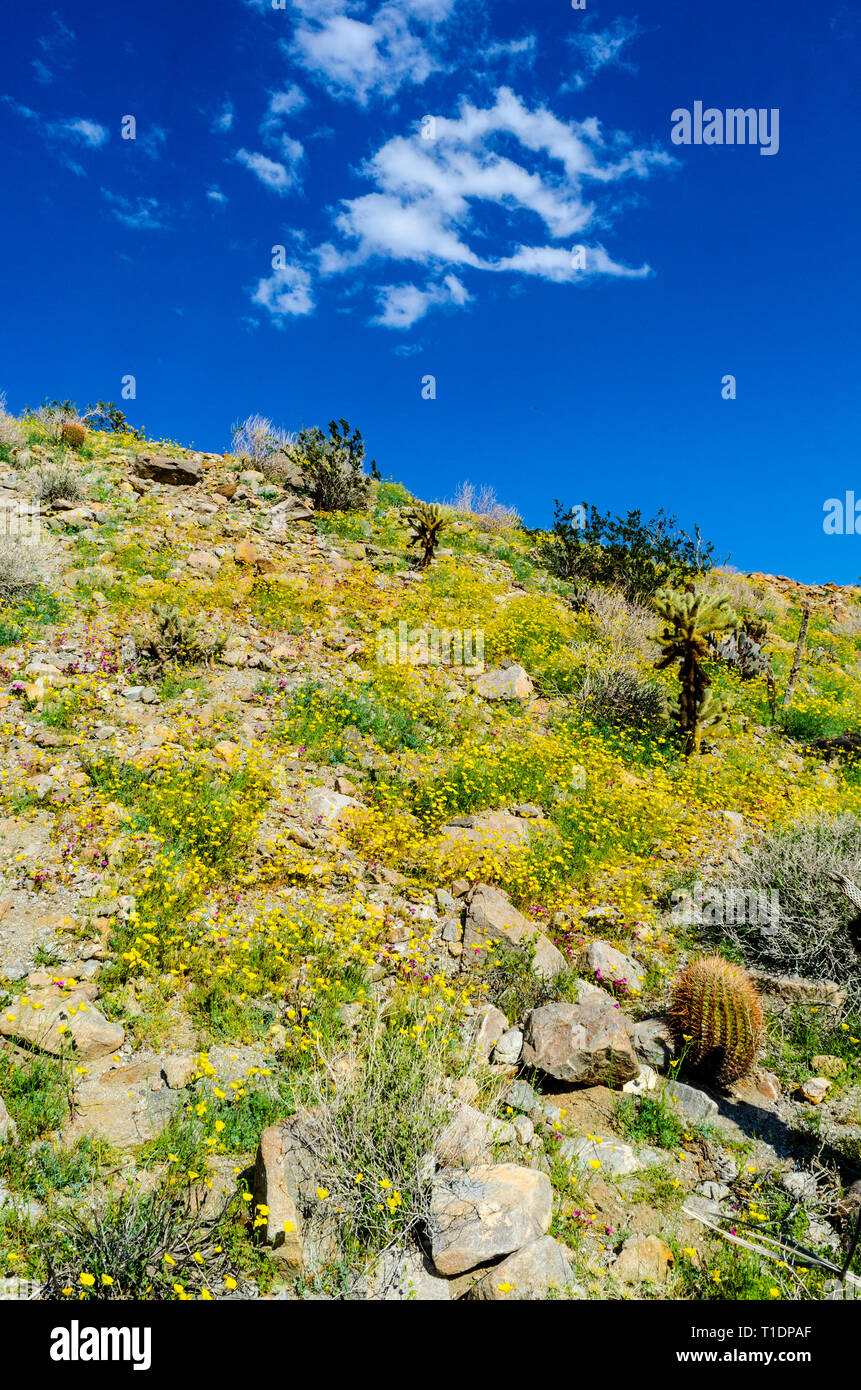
247, 88, 675, 329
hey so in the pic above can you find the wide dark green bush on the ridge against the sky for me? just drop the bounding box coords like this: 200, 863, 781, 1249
542, 500, 714, 600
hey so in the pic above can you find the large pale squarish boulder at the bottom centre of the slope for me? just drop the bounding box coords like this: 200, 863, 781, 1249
428, 1163, 552, 1277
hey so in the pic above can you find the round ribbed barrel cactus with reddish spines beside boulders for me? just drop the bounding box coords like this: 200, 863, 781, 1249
669, 956, 762, 1086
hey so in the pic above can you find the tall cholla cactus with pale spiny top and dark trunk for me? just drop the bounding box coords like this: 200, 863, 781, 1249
654, 589, 737, 758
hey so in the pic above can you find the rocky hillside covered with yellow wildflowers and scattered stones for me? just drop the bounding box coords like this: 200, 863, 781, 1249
0, 421, 861, 1300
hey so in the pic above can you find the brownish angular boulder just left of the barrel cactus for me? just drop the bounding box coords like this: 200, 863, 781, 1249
522, 999, 640, 1087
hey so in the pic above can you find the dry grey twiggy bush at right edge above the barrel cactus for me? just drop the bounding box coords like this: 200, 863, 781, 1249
722, 813, 861, 1008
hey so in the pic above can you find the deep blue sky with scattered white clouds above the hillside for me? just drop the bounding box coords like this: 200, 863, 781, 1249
0, 0, 861, 582
